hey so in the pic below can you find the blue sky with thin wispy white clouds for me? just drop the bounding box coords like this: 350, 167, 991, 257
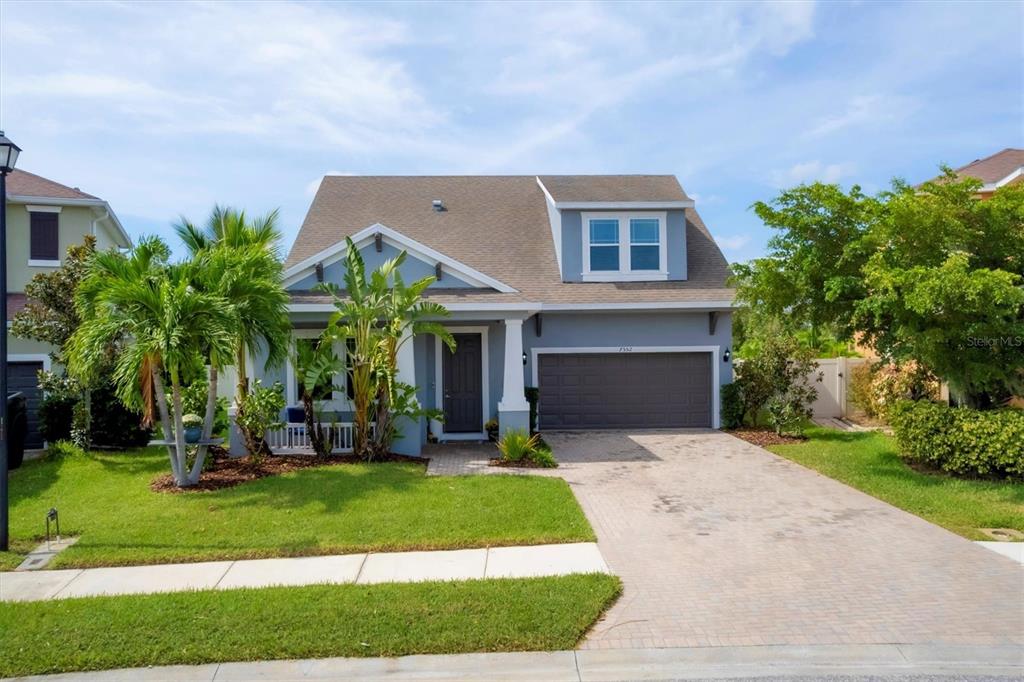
0, 0, 1024, 261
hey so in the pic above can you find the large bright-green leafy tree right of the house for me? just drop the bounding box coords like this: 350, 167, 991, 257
735, 169, 1024, 408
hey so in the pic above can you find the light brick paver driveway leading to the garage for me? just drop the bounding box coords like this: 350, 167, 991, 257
545, 431, 1024, 648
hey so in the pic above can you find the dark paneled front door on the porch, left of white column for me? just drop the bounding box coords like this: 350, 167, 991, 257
442, 334, 483, 433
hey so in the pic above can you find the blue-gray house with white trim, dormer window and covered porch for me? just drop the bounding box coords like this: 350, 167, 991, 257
254, 175, 733, 455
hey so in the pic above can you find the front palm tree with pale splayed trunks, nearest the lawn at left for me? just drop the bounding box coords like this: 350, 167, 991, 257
69, 238, 239, 486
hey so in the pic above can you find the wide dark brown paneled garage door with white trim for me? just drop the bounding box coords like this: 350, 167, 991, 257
538, 353, 712, 429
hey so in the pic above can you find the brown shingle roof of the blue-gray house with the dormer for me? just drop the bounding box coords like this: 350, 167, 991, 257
286, 175, 733, 303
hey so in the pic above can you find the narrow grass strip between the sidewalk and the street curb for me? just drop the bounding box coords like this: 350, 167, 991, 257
0, 574, 621, 677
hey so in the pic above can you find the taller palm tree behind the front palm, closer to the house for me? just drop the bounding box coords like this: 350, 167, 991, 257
175, 206, 291, 457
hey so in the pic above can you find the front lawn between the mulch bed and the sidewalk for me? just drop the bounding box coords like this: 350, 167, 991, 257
0, 449, 594, 569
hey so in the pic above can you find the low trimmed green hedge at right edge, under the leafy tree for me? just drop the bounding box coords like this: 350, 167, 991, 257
889, 400, 1024, 479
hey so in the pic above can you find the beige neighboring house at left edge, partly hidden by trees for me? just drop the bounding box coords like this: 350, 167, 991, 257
6, 170, 131, 447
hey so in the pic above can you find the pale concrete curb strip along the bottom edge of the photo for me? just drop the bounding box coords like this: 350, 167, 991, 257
9, 644, 1024, 682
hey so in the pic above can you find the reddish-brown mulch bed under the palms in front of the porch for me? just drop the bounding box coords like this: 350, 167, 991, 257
150, 447, 427, 493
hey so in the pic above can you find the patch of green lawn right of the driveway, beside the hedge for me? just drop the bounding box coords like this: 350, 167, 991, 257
769, 427, 1024, 540
